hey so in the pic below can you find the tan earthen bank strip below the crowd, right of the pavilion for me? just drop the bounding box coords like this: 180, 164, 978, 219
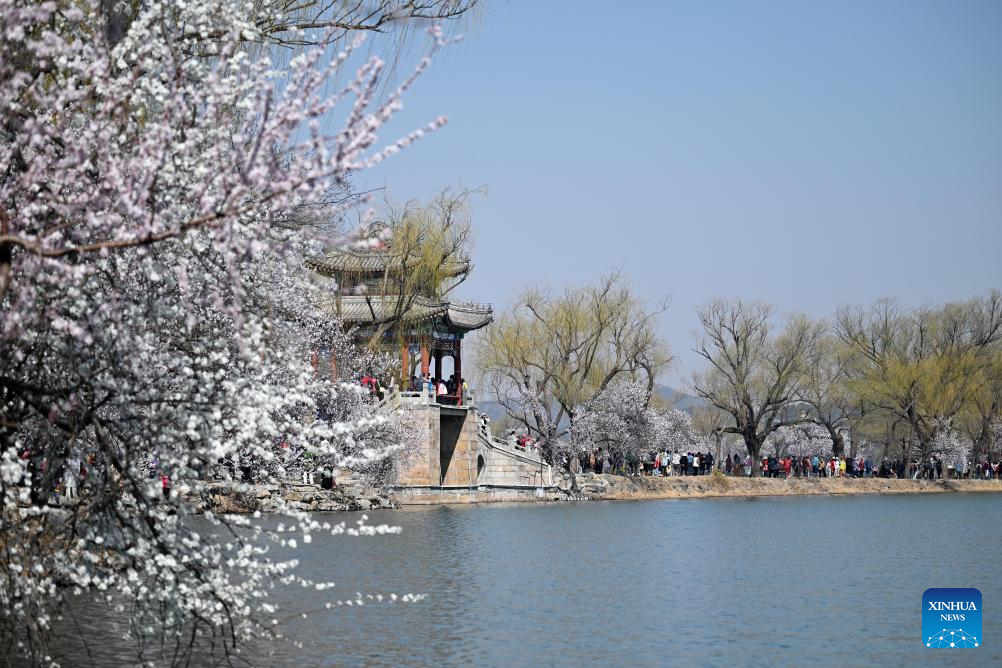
560, 474, 1002, 500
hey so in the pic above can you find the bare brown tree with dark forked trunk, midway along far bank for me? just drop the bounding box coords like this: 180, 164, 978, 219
693, 299, 824, 458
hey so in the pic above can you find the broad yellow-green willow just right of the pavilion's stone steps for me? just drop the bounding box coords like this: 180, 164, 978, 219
479, 272, 671, 456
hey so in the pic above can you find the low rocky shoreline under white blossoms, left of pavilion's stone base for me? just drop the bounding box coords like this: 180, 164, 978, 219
191, 483, 396, 514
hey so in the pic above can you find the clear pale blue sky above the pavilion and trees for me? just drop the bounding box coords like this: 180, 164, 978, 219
357, 0, 1002, 385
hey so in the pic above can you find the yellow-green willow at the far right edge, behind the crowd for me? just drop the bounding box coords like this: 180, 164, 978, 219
835, 290, 1002, 460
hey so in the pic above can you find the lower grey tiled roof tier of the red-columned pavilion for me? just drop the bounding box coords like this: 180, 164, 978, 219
331, 294, 494, 331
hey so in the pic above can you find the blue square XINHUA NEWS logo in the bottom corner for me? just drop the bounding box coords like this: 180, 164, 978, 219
922, 589, 981, 649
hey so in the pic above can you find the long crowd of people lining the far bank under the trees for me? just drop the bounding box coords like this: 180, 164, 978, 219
564, 448, 1002, 480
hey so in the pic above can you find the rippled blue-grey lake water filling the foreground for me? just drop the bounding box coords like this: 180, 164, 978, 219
41, 495, 1002, 666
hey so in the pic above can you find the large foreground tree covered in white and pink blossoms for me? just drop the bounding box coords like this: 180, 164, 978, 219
0, 0, 470, 663
